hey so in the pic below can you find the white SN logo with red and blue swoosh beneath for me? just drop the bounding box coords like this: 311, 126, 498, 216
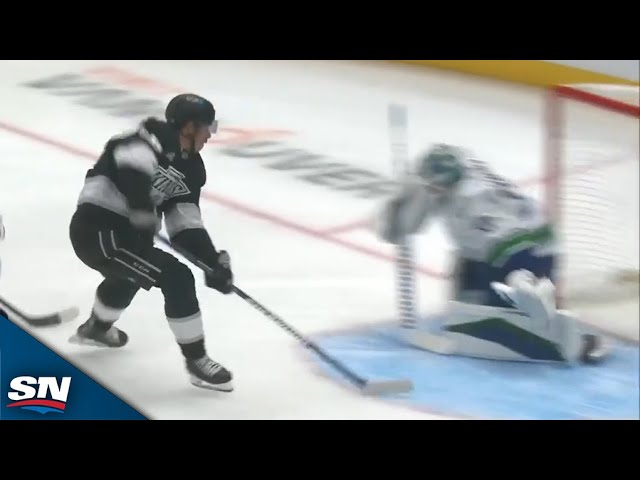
7, 376, 71, 415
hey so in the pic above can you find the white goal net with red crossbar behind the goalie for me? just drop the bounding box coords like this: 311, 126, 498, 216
544, 81, 640, 338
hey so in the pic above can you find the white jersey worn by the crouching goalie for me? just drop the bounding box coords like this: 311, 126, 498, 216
379, 158, 553, 266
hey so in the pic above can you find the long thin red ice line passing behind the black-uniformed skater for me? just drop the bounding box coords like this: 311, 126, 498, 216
0, 121, 448, 279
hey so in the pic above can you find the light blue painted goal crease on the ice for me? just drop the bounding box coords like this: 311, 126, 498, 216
314, 324, 640, 420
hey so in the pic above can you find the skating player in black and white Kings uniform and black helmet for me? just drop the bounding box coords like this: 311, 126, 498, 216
69, 94, 238, 391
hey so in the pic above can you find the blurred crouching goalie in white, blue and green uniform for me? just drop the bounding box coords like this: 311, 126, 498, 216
378, 144, 604, 362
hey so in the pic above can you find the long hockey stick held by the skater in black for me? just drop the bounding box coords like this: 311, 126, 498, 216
156, 235, 413, 395
